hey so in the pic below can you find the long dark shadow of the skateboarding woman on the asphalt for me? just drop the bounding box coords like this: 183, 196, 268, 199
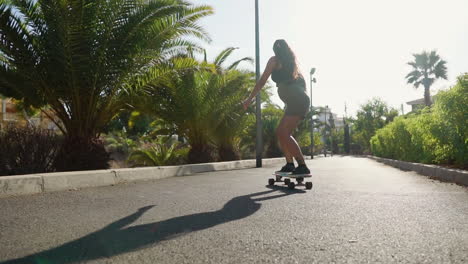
0, 189, 304, 264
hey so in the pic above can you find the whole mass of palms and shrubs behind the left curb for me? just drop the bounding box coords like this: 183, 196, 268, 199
0, 0, 320, 175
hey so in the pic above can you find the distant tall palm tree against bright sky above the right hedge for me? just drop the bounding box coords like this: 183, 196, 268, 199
406, 51, 447, 106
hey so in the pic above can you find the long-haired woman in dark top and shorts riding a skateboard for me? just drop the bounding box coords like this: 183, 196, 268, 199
243, 39, 310, 174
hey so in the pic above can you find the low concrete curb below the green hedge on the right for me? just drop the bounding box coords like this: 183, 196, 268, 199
367, 156, 468, 186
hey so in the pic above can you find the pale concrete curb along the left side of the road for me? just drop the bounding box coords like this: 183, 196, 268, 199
0, 158, 284, 198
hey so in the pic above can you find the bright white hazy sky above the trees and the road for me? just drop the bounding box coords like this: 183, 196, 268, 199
192, 0, 468, 116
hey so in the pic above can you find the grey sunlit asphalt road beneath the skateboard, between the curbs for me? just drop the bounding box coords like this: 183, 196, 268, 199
0, 157, 468, 264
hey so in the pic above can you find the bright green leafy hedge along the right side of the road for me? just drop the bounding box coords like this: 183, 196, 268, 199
371, 75, 468, 168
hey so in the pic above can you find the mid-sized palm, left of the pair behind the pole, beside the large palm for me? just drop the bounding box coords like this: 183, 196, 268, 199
138, 58, 218, 163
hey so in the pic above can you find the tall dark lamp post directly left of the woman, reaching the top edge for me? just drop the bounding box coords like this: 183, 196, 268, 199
255, 0, 263, 168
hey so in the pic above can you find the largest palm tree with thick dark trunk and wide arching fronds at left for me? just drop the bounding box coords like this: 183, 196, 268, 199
0, 0, 213, 170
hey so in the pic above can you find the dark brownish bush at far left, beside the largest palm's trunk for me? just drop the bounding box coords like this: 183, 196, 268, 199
0, 125, 62, 176
